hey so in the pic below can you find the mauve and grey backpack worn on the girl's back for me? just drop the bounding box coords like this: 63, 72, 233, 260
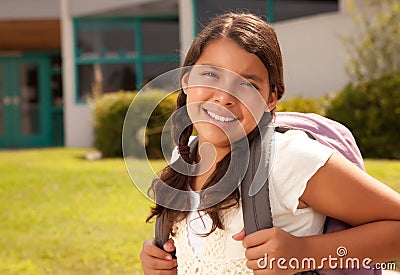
241, 112, 381, 275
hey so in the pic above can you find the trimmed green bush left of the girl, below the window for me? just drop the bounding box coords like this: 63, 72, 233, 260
91, 90, 176, 158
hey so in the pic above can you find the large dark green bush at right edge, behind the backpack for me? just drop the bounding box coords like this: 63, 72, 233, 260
326, 74, 400, 159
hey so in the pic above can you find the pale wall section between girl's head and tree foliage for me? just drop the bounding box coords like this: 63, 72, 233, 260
274, 13, 353, 97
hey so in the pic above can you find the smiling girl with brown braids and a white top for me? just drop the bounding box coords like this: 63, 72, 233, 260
140, 13, 400, 274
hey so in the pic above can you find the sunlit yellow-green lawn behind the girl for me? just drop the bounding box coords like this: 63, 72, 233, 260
0, 148, 400, 274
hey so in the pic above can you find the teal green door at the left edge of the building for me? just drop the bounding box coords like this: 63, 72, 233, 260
0, 57, 51, 148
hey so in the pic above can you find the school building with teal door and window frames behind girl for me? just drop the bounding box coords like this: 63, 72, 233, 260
0, 0, 363, 148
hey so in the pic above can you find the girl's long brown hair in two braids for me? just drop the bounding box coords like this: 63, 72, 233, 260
147, 13, 284, 234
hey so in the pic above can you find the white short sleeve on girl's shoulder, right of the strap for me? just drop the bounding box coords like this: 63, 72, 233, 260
269, 130, 334, 216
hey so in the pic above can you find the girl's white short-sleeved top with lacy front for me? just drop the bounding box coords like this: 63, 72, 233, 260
172, 130, 334, 274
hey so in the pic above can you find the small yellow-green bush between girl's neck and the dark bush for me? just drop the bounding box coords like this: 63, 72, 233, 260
277, 96, 328, 116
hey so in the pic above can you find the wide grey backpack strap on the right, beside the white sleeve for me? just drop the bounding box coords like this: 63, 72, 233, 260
240, 127, 275, 235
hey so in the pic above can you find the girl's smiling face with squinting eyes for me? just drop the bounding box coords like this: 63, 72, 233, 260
182, 38, 276, 147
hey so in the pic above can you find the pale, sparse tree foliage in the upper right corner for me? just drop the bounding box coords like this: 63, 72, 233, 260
344, 0, 400, 82
